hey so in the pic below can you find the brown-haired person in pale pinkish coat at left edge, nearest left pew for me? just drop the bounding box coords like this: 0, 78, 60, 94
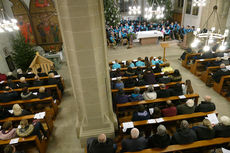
0, 121, 16, 140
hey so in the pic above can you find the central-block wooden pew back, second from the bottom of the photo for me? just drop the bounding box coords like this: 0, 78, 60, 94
120, 111, 218, 128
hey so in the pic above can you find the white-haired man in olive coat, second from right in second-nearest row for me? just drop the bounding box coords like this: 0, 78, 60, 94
177, 99, 195, 114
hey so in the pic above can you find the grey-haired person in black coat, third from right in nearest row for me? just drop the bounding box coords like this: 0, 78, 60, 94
171, 120, 197, 144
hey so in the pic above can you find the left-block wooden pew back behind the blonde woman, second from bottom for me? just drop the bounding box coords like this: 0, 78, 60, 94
0, 114, 53, 133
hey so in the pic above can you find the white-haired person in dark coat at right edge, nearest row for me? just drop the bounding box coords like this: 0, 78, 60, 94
213, 116, 230, 137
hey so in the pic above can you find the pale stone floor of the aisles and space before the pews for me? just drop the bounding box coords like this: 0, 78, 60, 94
47, 42, 230, 153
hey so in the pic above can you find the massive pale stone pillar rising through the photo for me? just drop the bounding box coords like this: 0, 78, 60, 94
56, 0, 116, 144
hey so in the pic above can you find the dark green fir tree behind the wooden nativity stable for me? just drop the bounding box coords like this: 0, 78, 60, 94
12, 34, 35, 71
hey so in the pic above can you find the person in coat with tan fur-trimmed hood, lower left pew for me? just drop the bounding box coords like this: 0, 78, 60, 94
16, 119, 47, 140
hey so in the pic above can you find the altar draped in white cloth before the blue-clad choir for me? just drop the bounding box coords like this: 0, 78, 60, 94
136, 30, 164, 45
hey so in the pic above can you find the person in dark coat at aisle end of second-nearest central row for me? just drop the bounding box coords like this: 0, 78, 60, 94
195, 96, 216, 112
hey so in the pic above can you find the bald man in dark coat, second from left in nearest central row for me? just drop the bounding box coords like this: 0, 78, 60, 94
121, 128, 147, 152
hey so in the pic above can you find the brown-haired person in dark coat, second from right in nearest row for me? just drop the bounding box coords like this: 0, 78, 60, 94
194, 119, 215, 140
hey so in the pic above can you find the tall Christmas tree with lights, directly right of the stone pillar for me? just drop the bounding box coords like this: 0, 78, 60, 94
104, 0, 120, 26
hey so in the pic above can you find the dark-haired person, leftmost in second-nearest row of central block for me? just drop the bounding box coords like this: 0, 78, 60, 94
132, 105, 150, 121
